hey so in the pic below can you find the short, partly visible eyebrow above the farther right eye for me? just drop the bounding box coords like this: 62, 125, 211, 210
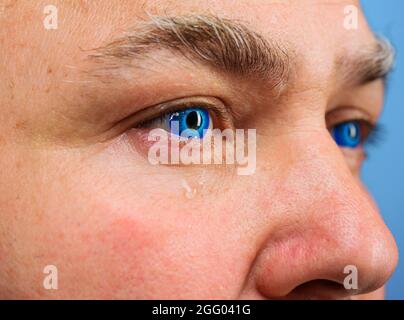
336, 37, 395, 85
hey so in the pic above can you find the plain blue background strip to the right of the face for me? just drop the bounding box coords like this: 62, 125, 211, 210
361, 0, 404, 299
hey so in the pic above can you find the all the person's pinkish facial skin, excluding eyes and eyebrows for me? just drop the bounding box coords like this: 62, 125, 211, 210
0, 0, 397, 299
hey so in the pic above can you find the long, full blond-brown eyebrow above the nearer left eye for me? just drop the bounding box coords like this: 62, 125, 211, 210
89, 15, 290, 87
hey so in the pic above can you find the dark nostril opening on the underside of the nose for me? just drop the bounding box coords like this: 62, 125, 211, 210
285, 279, 356, 300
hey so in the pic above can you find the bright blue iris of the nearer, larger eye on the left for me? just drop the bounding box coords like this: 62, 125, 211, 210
167, 108, 210, 138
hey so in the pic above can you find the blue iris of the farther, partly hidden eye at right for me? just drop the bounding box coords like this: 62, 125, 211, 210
331, 121, 362, 148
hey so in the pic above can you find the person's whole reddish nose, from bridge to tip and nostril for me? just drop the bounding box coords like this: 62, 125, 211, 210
246, 132, 397, 299
